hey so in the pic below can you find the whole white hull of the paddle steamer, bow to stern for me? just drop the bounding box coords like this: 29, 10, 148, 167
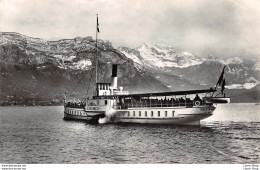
64, 106, 215, 125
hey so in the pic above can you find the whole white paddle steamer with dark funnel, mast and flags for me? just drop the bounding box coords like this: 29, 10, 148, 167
64, 15, 230, 125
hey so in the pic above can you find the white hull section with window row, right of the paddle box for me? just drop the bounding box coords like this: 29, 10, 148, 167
110, 106, 215, 125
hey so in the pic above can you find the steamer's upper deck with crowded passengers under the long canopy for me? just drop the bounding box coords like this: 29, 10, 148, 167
66, 89, 216, 109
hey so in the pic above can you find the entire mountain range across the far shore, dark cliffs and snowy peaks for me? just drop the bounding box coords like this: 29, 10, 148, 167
0, 32, 260, 105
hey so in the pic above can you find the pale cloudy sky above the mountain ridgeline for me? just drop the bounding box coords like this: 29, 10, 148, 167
0, 0, 260, 59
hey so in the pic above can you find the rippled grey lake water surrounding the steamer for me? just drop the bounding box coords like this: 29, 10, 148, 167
0, 104, 260, 164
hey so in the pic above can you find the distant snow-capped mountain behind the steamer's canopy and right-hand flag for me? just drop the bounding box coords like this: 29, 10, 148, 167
118, 43, 260, 89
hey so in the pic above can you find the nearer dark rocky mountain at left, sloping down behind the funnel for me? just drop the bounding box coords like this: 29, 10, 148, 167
0, 33, 168, 104
